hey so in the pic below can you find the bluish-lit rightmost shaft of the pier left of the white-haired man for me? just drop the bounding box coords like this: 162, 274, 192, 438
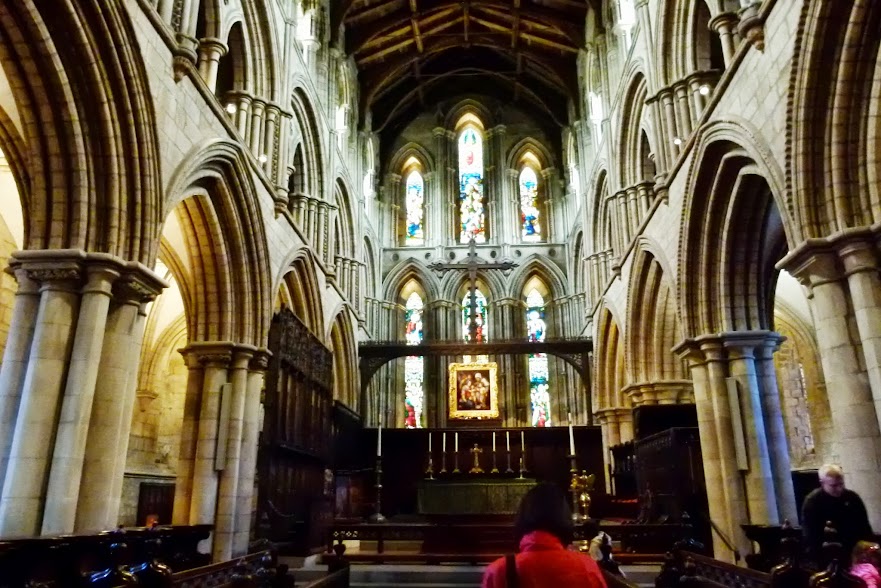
755, 333, 798, 523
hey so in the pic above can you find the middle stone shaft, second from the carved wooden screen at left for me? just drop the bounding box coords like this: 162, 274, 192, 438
212, 346, 256, 561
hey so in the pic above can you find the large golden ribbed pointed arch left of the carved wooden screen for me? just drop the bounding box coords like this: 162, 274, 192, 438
165, 140, 272, 347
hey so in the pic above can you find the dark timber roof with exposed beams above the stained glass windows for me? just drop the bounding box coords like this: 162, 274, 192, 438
332, 0, 599, 139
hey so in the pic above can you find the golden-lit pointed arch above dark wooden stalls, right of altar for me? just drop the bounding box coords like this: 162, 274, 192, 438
626, 237, 693, 406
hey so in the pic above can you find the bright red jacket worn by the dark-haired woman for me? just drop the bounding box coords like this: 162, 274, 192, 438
482, 531, 606, 588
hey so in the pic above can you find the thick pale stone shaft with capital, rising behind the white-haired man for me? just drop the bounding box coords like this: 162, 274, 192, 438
780, 246, 881, 529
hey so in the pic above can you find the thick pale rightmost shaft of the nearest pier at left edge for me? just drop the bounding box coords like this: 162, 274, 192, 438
74, 281, 152, 532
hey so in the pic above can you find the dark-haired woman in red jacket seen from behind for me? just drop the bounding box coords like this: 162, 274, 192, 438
482, 484, 606, 588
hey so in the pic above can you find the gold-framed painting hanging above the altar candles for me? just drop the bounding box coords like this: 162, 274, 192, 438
449, 361, 499, 419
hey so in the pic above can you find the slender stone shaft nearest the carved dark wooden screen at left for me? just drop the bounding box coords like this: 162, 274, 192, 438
233, 349, 269, 557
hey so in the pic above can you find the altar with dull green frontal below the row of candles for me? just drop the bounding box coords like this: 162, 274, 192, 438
416, 477, 536, 515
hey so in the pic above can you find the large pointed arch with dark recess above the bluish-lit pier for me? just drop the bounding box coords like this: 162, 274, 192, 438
678, 123, 789, 337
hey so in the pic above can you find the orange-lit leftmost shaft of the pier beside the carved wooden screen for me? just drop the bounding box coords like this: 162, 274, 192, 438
171, 348, 205, 525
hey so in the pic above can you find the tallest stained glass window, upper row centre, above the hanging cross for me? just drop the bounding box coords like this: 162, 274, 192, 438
459, 127, 486, 243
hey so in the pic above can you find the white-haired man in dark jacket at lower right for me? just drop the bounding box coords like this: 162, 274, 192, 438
802, 464, 872, 560
